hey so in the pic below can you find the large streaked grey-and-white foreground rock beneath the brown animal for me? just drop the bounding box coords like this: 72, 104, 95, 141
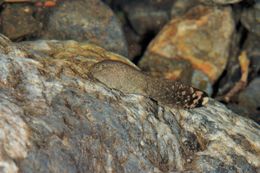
0, 37, 260, 173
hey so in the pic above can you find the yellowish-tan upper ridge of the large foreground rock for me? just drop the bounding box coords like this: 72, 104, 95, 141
16, 40, 134, 74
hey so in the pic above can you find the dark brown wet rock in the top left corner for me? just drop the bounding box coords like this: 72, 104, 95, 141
1, 4, 41, 40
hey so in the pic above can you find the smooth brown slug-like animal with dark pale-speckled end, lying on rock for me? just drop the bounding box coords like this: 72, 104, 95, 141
89, 60, 208, 108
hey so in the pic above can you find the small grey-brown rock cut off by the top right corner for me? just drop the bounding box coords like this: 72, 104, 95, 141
241, 0, 260, 36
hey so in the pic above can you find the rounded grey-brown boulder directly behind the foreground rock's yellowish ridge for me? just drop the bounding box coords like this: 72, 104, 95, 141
41, 0, 128, 56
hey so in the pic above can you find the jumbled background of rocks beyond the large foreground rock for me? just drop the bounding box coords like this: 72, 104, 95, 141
0, 0, 260, 123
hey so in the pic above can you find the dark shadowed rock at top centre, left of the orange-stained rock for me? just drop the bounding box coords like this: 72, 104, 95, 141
121, 0, 172, 35
